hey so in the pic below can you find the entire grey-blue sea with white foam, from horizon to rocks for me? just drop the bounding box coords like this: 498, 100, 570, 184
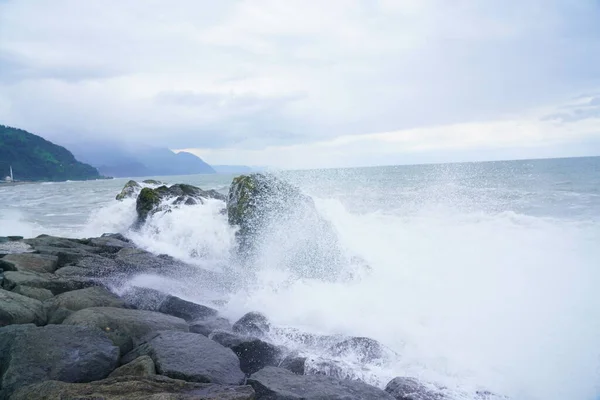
0, 157, 600, 400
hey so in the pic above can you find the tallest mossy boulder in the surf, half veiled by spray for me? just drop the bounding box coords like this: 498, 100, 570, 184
227, 174, 347, 279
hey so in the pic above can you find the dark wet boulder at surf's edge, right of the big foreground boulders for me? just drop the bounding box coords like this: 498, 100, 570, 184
209, 331, 283, 375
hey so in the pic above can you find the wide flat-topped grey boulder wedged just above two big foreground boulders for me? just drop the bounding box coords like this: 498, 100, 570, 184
63, 307, 188, 354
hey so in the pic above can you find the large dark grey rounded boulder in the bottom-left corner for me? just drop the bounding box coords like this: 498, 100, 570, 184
1, 325, 119, 398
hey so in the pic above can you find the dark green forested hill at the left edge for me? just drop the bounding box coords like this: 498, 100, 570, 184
0, 125, 101, 181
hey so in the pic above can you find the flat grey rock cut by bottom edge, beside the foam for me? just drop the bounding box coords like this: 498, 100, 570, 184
248, 367, 394, 400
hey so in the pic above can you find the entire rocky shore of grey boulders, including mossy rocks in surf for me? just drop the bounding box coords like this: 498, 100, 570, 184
0, 175, 502, 400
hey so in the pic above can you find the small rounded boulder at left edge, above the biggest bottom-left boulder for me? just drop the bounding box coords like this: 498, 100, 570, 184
0, 289, 47, 326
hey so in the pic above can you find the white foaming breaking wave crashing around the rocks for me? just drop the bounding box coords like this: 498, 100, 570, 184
79, 179, 600, 400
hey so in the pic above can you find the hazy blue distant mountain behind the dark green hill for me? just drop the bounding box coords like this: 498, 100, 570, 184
64, 142, 215, 177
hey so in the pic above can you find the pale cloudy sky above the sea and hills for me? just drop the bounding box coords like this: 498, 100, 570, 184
0, 0, 600, 168
